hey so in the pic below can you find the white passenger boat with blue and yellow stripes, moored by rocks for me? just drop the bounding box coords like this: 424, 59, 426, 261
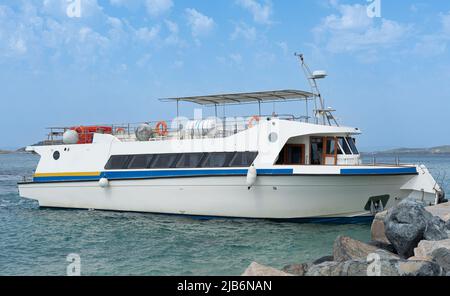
18, 56, 444, 222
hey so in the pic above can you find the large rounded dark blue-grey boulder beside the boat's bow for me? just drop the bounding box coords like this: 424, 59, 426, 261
384, 199, 433, 258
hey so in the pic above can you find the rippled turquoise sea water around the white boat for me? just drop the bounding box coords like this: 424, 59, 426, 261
0, 154, 450, 275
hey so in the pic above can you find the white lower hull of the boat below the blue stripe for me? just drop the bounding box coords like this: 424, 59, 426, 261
19, 175, 418, 219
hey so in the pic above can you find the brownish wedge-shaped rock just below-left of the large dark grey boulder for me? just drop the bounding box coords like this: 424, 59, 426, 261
333, 236, 399, 262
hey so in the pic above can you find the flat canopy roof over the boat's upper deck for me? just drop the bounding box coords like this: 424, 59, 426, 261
161, 90, 313, 105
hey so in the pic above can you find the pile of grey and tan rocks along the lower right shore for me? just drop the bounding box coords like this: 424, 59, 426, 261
242, 199, 450, 276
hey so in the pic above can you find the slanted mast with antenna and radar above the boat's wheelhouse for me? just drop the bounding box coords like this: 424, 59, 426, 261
295, 53, 339, 126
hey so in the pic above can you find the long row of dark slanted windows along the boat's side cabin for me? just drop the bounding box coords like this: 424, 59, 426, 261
105, 152, 258, 170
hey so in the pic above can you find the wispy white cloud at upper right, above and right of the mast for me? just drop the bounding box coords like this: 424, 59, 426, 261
313, 3, 410, 53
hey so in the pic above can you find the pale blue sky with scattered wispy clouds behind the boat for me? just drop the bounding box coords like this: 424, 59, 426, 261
0, 0, 450, 150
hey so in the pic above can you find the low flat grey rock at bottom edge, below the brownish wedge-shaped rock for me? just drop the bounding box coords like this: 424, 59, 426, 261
306, 260, 368, 276
